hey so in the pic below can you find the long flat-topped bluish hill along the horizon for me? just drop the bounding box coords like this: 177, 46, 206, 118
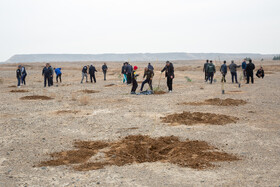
6, 53, 274, 63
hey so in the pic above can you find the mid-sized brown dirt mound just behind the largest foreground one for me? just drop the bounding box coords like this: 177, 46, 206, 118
161, 112, 238, 125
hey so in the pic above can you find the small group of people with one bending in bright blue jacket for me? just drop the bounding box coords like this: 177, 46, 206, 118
42, 63, 62, 87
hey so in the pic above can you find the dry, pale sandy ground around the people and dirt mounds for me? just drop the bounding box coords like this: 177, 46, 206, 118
0, 61, 280, 186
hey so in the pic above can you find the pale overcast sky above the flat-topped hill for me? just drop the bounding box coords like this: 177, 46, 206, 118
0, 0, 280, 61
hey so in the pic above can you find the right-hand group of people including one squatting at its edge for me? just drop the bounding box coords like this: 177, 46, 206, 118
203, 59, 264, 84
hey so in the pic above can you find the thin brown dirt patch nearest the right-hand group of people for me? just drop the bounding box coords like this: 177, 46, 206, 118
182, 98, 247, 106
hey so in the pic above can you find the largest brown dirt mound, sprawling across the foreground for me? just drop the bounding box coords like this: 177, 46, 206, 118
39, 135, 238, 171
